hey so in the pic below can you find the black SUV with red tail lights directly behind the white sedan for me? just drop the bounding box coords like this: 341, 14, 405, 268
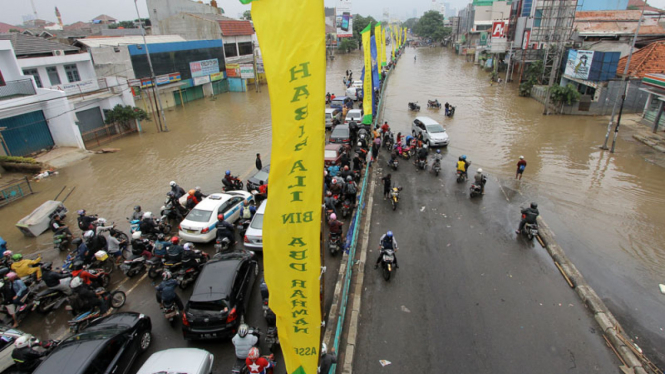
182, 250, 259, 340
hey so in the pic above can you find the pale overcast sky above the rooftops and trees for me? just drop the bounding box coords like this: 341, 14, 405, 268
0, 0, 665, 25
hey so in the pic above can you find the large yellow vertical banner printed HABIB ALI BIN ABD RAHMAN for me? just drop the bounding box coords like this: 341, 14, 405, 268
241, 0, 326, 374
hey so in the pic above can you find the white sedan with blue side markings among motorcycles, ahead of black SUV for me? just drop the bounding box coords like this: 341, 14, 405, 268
178, 191, 254, 243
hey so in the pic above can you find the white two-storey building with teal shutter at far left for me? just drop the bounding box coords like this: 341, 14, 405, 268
0, 33, 134, 156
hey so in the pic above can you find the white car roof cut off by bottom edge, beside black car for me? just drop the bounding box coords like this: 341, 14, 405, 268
136, 348, 210, 374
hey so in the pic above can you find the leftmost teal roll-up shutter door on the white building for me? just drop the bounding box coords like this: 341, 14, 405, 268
0, 110, 55, 156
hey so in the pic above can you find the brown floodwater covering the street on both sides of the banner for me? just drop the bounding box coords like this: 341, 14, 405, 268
0, 44, 665, 368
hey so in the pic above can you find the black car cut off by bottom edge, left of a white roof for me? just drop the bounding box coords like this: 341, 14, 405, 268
33, 312, 152, 374
